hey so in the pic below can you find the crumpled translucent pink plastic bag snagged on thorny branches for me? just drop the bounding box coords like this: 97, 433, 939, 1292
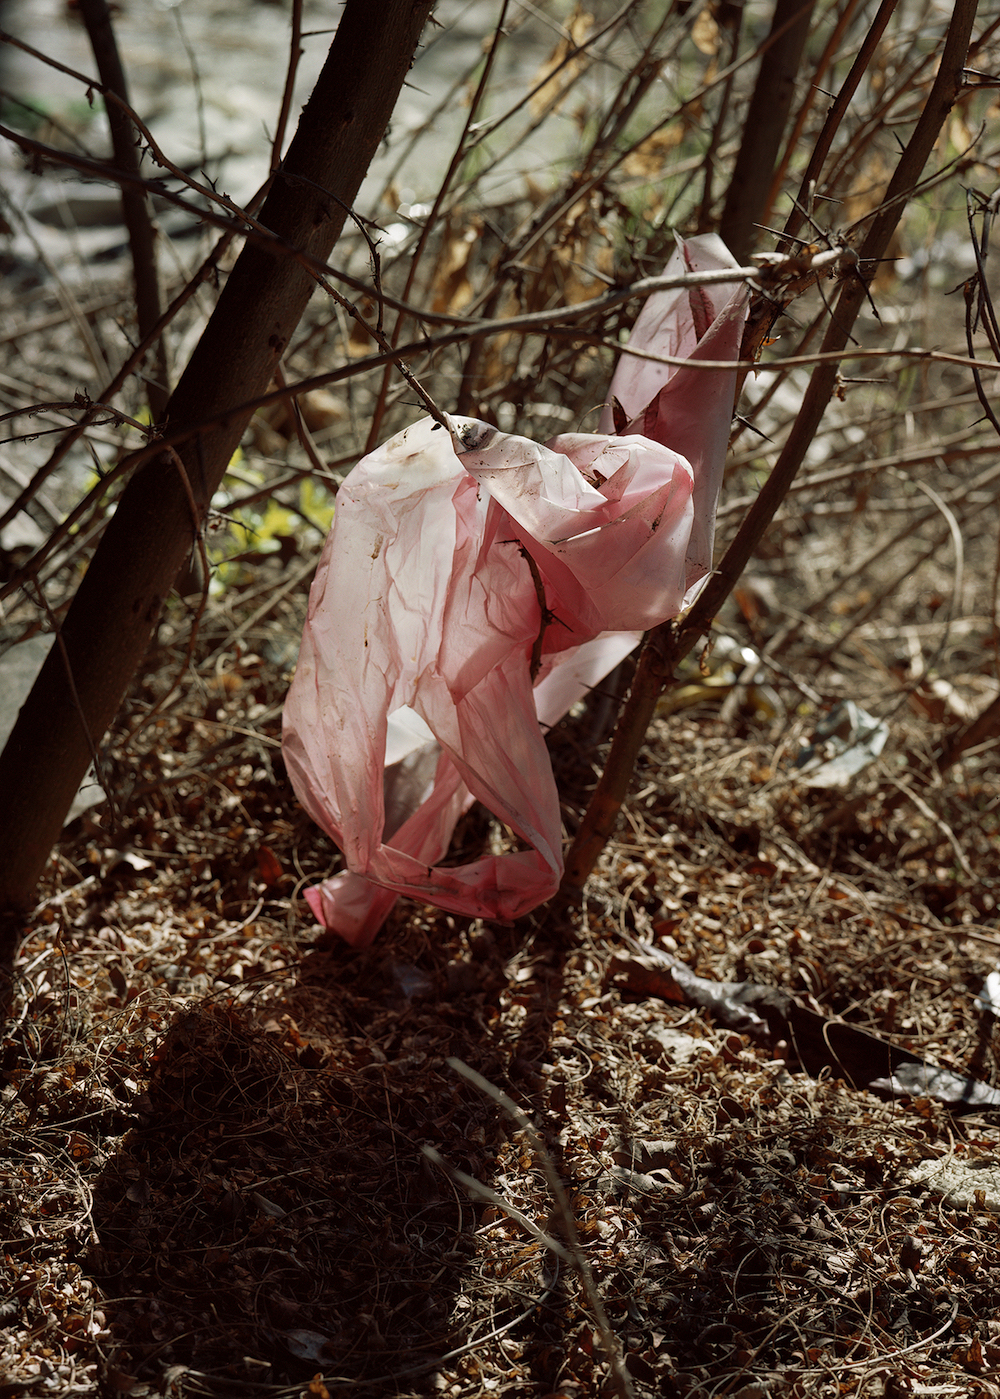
284, 238, 747, 946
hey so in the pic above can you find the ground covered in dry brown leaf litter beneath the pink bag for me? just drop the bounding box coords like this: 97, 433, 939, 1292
0, 593, 1000, 1399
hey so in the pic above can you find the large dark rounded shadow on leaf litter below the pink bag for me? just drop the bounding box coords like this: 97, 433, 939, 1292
88, 968, 511, 1392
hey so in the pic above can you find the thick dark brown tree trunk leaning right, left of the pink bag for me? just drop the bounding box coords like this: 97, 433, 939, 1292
0, 0, 432, 936
